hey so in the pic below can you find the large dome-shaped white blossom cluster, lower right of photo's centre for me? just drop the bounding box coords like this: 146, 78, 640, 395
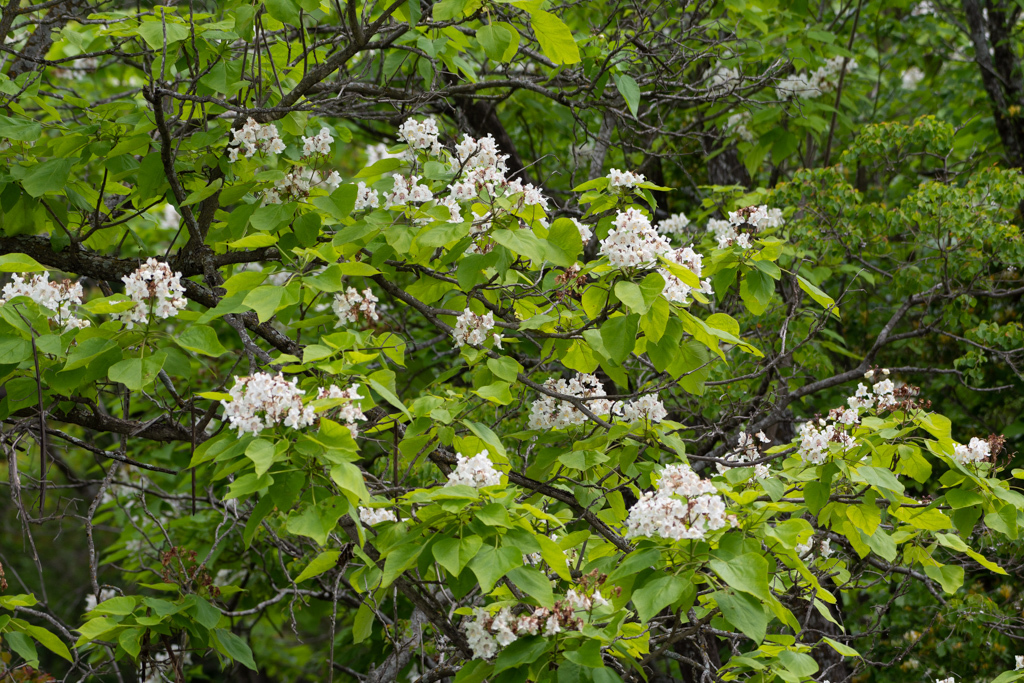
626, 465, 736, 541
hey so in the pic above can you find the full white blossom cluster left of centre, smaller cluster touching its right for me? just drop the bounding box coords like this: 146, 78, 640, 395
224, 373, 316, 436
